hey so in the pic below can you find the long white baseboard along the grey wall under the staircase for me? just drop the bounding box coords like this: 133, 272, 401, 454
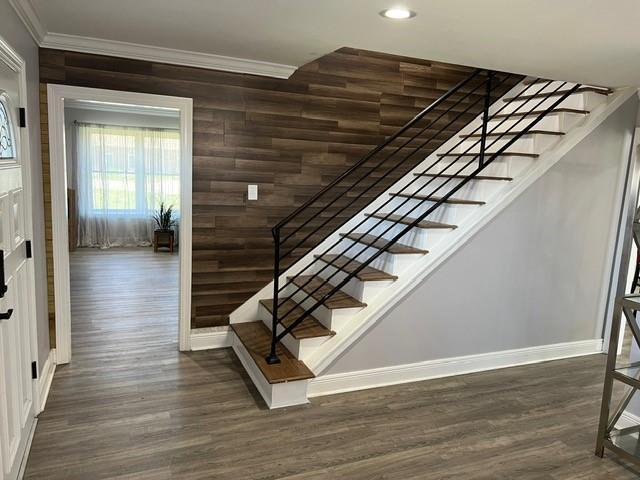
308, 339, 602, 397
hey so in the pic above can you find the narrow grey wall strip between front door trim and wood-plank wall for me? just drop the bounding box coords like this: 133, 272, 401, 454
0, 0, 50, 368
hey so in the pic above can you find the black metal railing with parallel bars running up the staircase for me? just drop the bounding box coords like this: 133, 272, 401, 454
267, 70, 579, 363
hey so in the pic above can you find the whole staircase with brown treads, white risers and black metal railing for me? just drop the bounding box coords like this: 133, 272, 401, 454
231, 70, 615, 408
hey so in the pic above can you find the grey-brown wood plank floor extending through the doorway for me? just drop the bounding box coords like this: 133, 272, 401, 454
25, 251, 640, 480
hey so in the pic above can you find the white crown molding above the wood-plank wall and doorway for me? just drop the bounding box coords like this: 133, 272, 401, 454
40, 33, 298, 79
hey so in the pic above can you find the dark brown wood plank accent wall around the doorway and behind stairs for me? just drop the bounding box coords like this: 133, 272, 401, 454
40, 48, 520, 327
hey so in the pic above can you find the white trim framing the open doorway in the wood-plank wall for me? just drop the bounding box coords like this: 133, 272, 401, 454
47, 84, 193, 363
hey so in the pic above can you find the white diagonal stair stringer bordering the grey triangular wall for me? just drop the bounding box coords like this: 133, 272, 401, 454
305, 88, 637, 378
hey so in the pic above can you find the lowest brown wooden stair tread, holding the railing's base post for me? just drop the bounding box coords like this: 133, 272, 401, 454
231, 322, 315, 384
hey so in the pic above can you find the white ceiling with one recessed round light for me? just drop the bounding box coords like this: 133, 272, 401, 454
12, 0, 640, 86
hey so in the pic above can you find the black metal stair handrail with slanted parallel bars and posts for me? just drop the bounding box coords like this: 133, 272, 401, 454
267, 69, 579, 363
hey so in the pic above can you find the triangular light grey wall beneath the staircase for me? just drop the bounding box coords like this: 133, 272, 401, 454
323, 95, 638, 374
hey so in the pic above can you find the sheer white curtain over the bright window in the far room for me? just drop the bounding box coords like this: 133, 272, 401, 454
75, 123, 180, 248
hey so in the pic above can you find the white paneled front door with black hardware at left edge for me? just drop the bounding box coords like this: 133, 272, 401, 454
0, 47, 35, 480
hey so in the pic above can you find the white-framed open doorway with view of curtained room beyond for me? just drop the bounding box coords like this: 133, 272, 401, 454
48, 85, 192, 363
